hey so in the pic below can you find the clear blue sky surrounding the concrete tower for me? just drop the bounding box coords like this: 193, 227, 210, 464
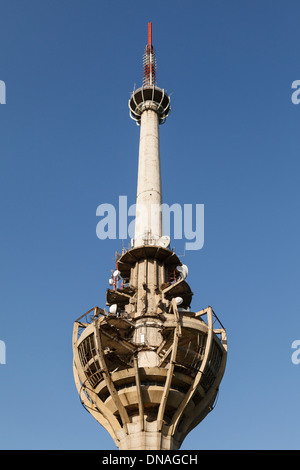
0, 0, 300, 449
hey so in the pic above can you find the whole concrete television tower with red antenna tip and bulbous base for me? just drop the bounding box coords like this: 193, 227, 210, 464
73, 23, 227, 450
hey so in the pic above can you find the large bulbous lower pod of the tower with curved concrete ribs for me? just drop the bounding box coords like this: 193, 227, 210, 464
73, 299, 227, 450
